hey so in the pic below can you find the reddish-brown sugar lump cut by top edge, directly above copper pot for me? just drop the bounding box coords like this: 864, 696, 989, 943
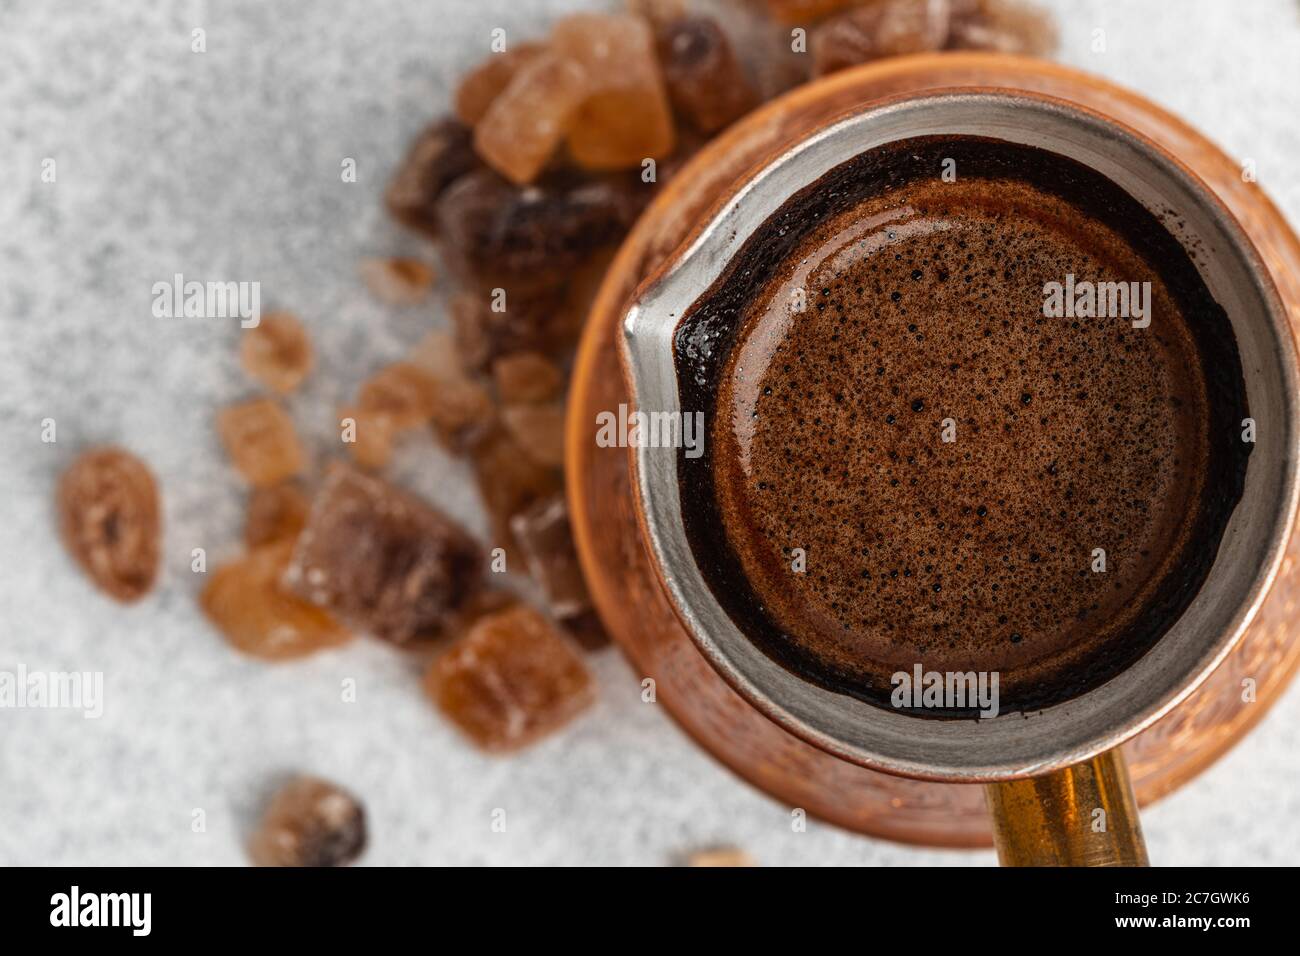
811, 0, 952, 77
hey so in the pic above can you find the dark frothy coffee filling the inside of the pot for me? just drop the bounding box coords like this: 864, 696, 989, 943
675, 137, 1251, 715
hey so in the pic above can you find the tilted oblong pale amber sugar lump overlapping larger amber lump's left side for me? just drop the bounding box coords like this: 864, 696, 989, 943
475, 51, 589, 185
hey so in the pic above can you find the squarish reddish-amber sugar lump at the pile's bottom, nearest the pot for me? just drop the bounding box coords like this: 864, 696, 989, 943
425, 605, 594, 753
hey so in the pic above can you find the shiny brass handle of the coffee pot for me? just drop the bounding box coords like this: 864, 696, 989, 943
984, 748, 1149, 866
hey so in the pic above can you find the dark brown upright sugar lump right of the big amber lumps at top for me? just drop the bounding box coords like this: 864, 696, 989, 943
658, 17, 758, 133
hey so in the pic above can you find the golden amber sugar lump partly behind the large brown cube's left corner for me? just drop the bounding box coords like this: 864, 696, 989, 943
199, 538, 351, 661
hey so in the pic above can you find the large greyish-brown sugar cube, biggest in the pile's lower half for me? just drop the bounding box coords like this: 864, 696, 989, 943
283, 464, 484, 644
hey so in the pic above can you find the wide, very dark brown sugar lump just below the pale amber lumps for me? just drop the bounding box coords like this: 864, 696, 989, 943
438, 169, 654, 293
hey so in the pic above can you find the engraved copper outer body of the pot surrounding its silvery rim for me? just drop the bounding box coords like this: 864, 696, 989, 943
568, 53, 1300, 847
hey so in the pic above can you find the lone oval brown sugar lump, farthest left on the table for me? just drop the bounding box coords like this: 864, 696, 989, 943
56, 447, 163, 602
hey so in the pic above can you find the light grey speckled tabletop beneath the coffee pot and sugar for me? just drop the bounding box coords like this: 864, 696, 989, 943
0, 0, 1300, 865
